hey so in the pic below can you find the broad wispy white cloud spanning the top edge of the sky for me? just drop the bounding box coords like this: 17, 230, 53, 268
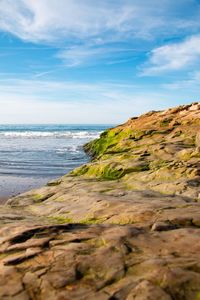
0, 0, 199, 44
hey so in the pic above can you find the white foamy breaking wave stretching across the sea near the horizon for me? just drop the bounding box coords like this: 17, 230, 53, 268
0, 131, 101, 139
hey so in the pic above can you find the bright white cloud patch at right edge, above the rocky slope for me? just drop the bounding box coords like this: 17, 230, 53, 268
142, 35, 200, 75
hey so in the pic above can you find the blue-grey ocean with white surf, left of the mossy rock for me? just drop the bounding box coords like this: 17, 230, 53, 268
0, 125, 113, 196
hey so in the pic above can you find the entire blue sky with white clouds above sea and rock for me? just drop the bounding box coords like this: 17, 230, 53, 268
0, 0, 200, 124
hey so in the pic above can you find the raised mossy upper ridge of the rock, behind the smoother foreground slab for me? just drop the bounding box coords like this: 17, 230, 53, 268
72, 103, 200, 199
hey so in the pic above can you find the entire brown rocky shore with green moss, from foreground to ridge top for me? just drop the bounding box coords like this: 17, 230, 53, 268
0, 103, 200, 300
